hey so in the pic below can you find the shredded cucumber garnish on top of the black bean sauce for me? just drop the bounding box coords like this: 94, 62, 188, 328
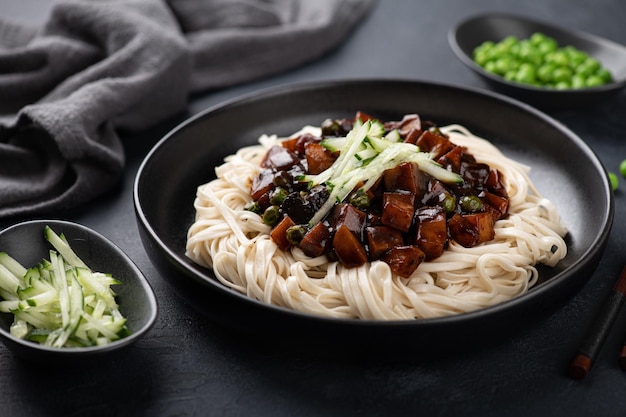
298, 120, 463, 226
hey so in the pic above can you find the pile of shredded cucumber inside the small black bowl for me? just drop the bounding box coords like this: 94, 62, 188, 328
0, 226, 129, 348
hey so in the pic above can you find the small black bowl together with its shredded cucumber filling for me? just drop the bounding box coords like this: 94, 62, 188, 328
0, 220, 157, 360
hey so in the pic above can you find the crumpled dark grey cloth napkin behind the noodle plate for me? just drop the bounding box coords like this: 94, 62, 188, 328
0, 0, 374, 217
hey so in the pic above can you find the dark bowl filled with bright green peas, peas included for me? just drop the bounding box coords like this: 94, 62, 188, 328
448, 14, 626, 110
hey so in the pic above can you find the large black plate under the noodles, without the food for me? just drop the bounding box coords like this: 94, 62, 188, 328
134, 80, 613, 356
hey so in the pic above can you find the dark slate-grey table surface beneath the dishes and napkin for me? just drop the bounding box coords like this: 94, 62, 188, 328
0, 0, 626, 417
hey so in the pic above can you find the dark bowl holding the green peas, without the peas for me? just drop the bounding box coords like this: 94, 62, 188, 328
448, 14, 626, 110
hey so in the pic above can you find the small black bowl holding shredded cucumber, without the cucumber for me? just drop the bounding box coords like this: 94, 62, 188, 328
0, 220, 157, 363
